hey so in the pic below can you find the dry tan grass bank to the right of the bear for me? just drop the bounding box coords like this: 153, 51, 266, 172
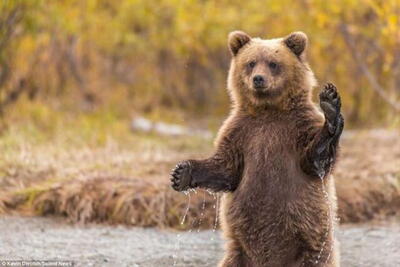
335, 130, 400, 222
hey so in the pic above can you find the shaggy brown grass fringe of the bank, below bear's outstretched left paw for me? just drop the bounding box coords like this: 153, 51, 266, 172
0, 177, 216, 229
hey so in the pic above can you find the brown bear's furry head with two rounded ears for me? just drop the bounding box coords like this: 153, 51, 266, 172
228, 31, 315, 111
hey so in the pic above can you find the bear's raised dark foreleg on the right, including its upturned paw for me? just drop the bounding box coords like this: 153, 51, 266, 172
301, 83, 344, 178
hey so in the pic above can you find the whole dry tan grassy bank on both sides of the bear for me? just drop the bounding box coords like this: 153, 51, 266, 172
0, 125, 400, 229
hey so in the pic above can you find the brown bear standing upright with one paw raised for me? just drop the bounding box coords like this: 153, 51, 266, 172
171, 31, 344, 267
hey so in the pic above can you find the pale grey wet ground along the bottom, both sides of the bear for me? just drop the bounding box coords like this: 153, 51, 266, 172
0, 217, 400, 267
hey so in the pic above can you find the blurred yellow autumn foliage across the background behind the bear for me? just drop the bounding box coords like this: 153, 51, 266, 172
0, 0, 400, 125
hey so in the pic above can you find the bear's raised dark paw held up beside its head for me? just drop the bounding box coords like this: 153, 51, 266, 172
319, 83, 342, 135
